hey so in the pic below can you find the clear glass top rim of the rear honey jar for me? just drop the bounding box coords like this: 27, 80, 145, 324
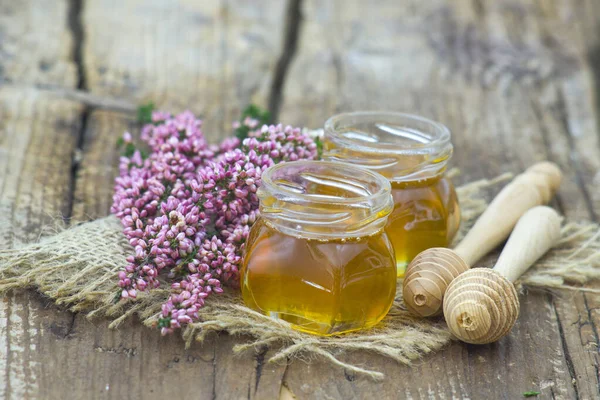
324, 111, 452, 155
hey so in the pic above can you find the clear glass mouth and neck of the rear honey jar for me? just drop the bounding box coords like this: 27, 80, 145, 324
323, 111, 453, 181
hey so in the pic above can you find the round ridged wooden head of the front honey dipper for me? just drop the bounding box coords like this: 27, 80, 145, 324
444, 268, 519, 344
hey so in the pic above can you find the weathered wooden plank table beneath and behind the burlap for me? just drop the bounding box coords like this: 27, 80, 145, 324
0, 0, 600, 399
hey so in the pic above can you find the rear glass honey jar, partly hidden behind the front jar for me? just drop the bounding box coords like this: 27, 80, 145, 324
323, 112, 460, 277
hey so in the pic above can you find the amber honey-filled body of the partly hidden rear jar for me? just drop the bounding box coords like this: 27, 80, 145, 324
386, 177, 460, 277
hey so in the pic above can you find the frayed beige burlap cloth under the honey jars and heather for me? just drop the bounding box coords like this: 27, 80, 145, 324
0, 174, 600, 379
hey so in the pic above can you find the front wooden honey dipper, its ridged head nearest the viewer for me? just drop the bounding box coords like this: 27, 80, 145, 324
444, 206, 561, 344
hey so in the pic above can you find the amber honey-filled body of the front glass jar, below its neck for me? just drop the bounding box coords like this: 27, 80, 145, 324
241, 219, 396, 335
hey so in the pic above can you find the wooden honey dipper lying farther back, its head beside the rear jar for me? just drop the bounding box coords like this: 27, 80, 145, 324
402, 161, 562, 317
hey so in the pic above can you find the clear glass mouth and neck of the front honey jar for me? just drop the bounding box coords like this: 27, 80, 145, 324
258, 161, 393, 238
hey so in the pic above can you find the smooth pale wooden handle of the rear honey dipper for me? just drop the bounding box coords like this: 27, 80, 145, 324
454, 161, 562, 266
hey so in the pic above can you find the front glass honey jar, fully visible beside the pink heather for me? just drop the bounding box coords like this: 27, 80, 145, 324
240, 161, 396, 336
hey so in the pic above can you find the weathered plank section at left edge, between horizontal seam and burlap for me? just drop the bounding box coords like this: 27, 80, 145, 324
0, 88, 82, 247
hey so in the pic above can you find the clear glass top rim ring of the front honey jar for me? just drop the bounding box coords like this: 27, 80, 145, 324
261, 160, 391, 204
